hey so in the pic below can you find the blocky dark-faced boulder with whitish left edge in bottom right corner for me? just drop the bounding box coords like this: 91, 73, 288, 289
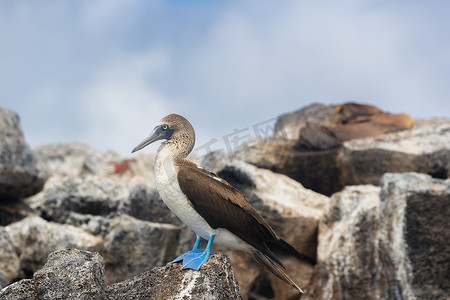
380, 173, 450, 299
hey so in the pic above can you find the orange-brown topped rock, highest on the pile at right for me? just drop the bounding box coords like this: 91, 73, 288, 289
274, 102, 414, 142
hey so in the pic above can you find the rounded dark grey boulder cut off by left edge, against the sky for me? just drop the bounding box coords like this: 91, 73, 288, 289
0, 107, 48, 200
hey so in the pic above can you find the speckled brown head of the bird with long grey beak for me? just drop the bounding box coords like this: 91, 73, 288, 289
131, 114, 195, 156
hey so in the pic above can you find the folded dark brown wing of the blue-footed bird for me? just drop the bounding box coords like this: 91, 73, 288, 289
177, 159, 280, 262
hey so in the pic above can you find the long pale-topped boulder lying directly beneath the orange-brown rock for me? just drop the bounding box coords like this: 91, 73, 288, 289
234, 110, 450, 195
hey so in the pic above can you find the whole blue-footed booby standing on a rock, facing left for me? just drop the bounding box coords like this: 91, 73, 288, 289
132, 114, 315, 292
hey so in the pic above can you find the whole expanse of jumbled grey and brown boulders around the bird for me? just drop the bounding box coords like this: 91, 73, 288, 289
0, 103, 450, 299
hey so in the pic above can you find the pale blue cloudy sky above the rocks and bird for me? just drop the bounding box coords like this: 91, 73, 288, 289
0, 0, 450, 156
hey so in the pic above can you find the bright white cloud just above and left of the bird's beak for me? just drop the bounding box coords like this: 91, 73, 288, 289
80, 50, 170, 154
